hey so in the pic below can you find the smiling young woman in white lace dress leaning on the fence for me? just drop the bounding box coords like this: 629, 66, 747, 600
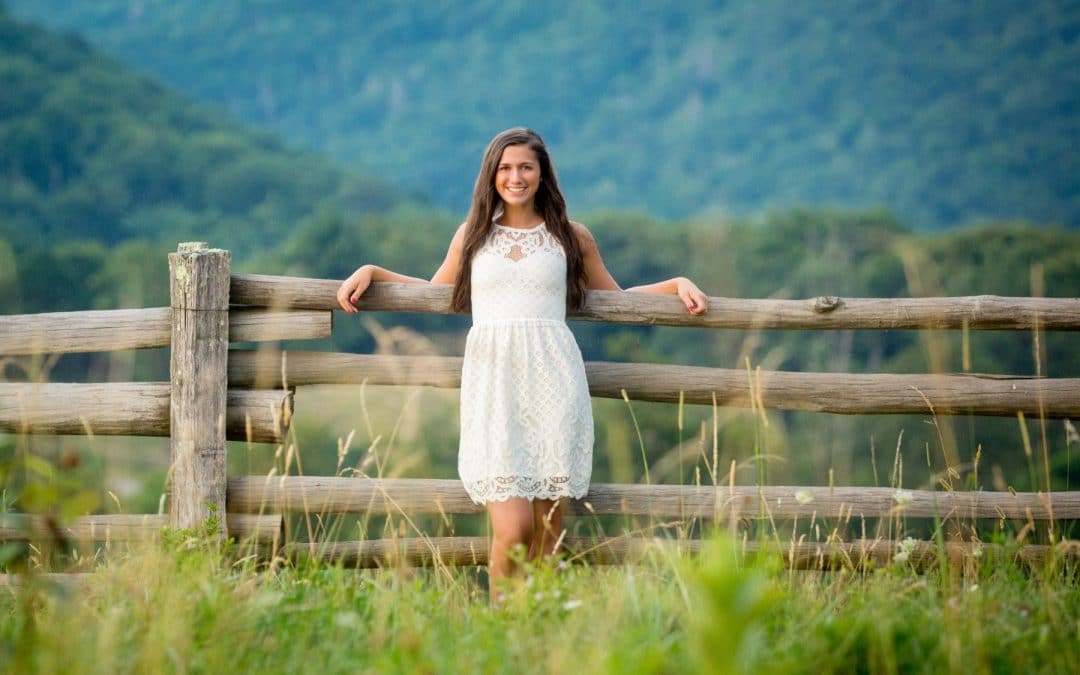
337, 129, 707, 581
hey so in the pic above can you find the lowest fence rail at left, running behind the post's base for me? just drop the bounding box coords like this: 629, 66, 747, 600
0, 513, 285, 543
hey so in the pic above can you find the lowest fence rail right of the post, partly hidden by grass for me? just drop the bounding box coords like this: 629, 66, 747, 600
286, 537, 1067, 570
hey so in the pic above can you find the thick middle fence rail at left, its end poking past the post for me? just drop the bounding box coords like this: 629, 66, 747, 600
0, 382, 293, 443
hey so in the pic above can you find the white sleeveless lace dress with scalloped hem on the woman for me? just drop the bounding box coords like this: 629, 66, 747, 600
458, 224, 593, 503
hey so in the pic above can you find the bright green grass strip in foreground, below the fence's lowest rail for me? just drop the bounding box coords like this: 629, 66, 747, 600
0, 541, 1080, 674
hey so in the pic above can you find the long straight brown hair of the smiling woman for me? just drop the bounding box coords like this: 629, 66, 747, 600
450, 126, 588, 312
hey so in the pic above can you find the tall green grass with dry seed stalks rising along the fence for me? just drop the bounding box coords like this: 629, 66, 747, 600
0, 265, 1080, 673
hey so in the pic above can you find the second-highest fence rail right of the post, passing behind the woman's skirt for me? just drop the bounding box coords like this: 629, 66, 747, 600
228, 350, 1080, 418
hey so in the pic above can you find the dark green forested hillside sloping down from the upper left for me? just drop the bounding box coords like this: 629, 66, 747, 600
0, 8, 400, 258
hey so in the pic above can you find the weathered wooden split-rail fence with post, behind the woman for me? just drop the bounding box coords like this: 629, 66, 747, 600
0, 243, 1080, 568
